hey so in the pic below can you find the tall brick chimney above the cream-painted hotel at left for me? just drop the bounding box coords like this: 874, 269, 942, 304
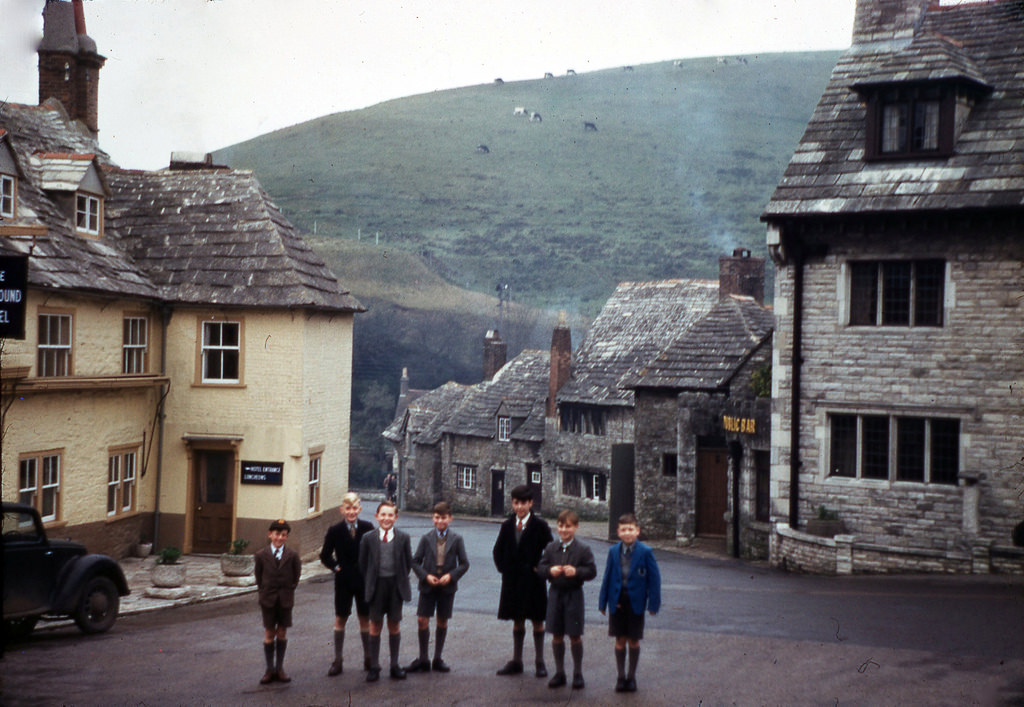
39, 0, 106, 135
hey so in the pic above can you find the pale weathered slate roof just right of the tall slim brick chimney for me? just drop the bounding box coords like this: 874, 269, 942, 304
558, 280, 718, 406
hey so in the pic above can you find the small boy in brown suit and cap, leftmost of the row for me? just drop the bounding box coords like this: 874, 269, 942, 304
255, 519, 302, 684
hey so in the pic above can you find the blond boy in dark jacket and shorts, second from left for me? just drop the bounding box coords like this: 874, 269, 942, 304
321, 492, 374, 676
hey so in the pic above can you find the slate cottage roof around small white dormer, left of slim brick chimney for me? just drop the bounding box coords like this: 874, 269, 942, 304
438, 350, 551, 442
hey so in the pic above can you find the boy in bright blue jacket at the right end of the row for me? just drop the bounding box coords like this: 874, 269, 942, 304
598, 513, 662, 693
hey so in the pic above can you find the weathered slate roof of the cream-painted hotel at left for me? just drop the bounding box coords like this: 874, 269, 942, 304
0, 101, 364, 311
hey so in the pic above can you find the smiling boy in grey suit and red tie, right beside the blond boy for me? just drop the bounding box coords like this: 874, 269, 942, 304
359, 501, 413, 682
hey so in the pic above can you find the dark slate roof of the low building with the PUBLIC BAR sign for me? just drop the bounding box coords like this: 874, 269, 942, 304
620, 295, 775, 390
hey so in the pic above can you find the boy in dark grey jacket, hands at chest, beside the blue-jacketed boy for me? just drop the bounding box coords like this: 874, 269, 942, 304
537, 509, 597, 690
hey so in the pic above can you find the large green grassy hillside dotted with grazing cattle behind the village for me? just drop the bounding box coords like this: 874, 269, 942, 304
216, 52, 838, 316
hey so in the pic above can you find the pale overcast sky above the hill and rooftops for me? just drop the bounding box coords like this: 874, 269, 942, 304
0, 0, 855, 168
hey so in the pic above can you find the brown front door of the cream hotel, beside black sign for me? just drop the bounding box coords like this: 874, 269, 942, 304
191, 450, 234, 553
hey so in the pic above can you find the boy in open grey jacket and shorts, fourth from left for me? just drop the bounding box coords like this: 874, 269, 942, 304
406, 501, 469, 672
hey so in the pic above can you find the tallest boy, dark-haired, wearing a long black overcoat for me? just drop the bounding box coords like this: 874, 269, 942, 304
494, 485, 551, 677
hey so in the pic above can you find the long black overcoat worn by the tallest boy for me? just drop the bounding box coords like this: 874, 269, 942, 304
494, 513, 551, 621
